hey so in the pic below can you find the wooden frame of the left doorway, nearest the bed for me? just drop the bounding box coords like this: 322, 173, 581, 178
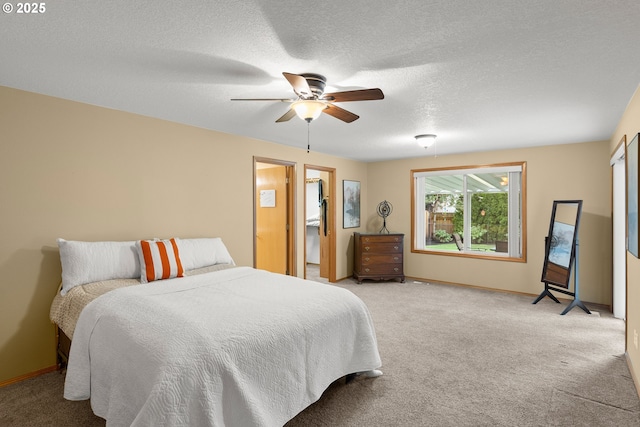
253, 156, 297, 276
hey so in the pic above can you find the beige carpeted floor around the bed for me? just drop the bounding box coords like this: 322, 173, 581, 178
0, 272, 640, 427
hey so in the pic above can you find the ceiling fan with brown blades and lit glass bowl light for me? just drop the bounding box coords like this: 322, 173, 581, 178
231, 73, 384, 123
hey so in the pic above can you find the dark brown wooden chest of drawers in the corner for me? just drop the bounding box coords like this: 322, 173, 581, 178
353, 233, 404, 283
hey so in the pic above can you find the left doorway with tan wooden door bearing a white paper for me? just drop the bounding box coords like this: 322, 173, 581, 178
253, 157, 296, 276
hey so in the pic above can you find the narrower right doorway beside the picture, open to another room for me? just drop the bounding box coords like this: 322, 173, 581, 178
304, 165, 336, 282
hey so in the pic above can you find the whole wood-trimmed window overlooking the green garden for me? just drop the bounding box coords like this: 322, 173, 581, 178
411, 162, 526, 261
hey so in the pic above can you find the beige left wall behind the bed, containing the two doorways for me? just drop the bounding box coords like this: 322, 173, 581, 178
0, 87, 367, 382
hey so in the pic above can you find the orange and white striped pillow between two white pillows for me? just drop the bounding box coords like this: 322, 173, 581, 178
136, 239, 184, 283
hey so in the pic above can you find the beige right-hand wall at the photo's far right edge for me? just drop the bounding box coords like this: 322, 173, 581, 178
609, 87, 640, 388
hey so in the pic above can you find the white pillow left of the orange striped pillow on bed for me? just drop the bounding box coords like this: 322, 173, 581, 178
58, 239, 140, 295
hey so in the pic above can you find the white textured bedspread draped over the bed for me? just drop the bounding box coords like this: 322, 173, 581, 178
64, 267, 381, 427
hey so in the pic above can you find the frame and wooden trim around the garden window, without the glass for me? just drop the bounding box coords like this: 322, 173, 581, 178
410, 162, 527, 262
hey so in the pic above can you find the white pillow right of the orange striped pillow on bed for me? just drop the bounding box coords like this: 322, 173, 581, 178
176, 237, 235, 271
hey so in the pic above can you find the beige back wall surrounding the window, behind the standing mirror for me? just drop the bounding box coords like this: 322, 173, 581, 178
365, 141, 612, 304
